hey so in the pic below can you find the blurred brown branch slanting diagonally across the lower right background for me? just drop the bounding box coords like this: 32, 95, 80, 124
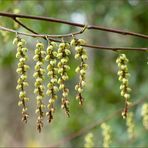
52, 98, 146, 147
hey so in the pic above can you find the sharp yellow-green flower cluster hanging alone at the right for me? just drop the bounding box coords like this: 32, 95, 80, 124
116, 54, 131, 118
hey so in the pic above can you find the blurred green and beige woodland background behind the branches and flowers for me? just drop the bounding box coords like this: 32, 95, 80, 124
0, 0, 148, 147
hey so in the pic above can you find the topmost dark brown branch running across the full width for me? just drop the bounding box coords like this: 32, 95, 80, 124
0, 12, 148, 39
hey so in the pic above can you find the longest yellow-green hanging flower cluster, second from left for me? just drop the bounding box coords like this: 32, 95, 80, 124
33, 42, 46, 132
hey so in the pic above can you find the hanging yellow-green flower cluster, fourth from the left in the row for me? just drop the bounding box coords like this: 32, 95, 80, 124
57, 42, 71, 116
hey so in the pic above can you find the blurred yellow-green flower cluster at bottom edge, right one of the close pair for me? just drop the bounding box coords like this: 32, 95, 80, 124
101, 123, 111, 148
